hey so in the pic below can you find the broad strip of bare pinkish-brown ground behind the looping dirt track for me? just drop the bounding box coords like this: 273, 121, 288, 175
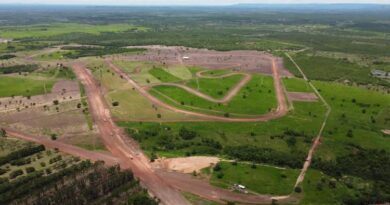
125, 46, 292, 76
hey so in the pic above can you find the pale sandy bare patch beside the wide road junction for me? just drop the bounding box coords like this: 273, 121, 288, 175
152, 156, 220, 173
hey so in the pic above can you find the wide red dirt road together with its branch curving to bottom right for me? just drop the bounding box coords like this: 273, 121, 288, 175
73, 63, 278, 205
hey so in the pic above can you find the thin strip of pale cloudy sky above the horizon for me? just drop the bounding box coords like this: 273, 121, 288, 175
0, 0, 390, 5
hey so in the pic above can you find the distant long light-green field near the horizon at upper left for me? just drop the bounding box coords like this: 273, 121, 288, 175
0, 23, 147, 39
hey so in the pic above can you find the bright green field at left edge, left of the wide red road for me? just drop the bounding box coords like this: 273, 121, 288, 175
0, 76, 54, 97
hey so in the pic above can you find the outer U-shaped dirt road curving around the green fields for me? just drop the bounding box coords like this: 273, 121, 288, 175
105, 58, 288, 122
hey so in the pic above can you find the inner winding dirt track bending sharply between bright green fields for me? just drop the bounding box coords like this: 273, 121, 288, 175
147, 73, 252, 104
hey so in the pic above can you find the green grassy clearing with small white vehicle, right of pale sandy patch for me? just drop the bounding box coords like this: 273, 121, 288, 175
210, 162, 299, 195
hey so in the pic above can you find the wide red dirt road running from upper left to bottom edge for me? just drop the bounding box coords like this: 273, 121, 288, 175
73, 63, 190, 205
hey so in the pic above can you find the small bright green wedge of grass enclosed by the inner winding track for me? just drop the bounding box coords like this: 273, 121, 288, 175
186, 74, 243, 99
